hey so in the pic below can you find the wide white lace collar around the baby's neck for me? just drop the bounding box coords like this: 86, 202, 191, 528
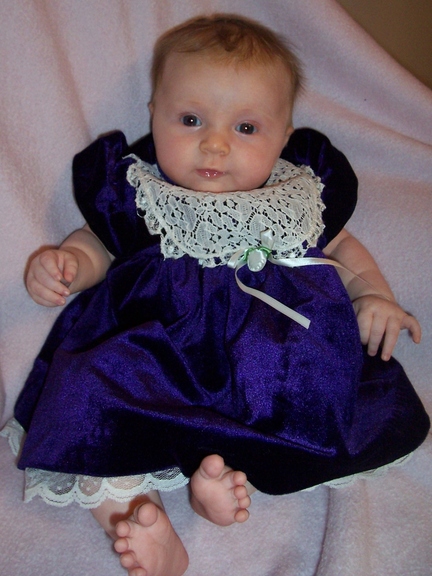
127, 155, 325, 267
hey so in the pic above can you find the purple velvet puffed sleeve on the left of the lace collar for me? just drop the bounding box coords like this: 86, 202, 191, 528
73, 132, 156, 257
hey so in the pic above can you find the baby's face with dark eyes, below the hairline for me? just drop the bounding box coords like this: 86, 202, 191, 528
150, 53, 292, 192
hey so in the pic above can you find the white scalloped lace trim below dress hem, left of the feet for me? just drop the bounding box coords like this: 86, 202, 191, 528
0, 419, 189, 508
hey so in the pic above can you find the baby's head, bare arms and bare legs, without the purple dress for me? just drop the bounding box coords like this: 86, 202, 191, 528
17, 15, 421, 576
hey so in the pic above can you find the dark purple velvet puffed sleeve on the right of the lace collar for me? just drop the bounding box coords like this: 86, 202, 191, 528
282, 128, 358, 248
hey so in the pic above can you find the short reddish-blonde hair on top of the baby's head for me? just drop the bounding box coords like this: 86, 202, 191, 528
151, 14, 302, 100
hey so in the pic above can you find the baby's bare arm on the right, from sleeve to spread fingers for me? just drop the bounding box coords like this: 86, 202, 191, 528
324, 229, 421, 360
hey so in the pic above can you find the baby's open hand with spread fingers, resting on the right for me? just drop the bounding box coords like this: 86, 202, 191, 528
353, 294, 421, 360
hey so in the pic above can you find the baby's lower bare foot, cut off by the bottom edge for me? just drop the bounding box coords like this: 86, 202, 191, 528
114, 502, 189, 576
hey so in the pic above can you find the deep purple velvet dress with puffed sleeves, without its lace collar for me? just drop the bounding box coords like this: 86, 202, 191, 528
15, 129, 429, 494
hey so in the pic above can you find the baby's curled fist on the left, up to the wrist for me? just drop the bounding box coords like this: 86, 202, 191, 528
26, 249, 78, 307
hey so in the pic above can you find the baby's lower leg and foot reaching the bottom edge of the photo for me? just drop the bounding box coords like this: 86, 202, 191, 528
92, 492, 189, 576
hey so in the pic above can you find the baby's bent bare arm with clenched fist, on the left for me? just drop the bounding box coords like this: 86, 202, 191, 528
26, 224, 112, 306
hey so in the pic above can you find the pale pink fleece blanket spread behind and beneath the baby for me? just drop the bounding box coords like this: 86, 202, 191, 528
0, 0, 432, 576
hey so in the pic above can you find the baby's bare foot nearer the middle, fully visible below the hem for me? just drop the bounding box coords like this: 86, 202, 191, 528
190, 454, 254, 526
